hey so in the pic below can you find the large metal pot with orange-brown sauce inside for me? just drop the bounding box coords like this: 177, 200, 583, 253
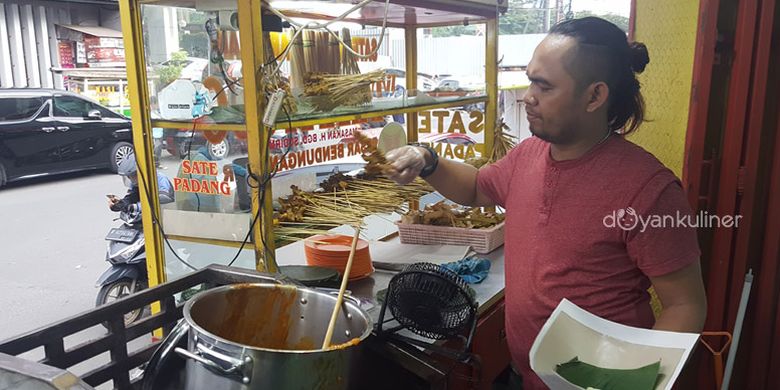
176, 284, 372, 390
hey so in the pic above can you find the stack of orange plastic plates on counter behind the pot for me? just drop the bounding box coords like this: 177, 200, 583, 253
304, 235, 374, 280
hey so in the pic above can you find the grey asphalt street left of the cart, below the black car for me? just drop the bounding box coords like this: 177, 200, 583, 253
0, 155, 178, 384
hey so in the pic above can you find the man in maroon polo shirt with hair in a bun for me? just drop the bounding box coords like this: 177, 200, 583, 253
387, 18, 706, 390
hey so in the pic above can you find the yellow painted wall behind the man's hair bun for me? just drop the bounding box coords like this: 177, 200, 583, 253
629, 0, 699, 177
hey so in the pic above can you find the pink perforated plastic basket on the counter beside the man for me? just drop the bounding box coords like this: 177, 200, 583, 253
396, 222, 504, 254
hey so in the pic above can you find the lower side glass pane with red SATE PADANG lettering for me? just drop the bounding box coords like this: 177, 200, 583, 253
152, 126, 254, 278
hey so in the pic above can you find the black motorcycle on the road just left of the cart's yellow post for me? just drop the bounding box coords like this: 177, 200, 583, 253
95, 207, 149, 326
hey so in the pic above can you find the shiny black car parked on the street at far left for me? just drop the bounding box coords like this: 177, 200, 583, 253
0, 89, 133, 186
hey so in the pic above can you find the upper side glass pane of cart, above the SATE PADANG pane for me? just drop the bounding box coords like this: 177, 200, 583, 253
142, 0, 244, 124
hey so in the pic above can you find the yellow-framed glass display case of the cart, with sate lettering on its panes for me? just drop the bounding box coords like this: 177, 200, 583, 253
120, 0, 502, 285
